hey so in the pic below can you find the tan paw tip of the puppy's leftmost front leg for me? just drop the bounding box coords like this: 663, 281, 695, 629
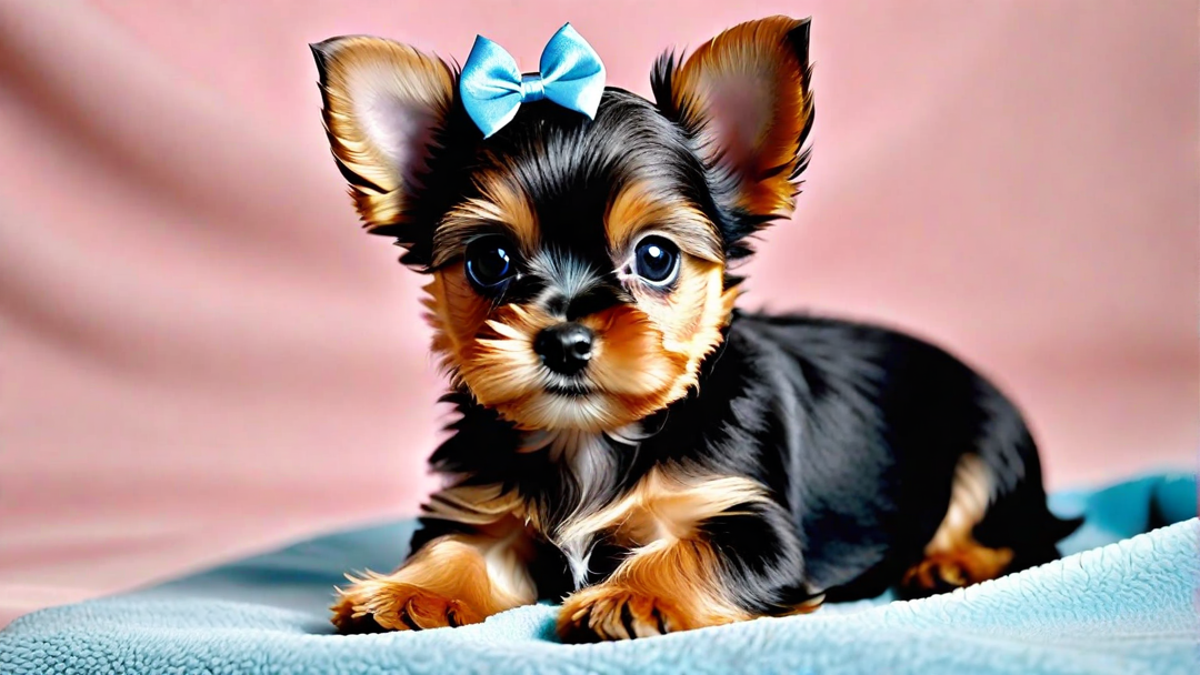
330, 574, 486, 634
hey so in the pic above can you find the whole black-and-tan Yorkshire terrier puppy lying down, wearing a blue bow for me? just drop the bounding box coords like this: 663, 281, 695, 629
313, 17, 1078, 641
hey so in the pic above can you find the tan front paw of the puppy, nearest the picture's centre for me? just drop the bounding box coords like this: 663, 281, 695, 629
558, 584, 690, 643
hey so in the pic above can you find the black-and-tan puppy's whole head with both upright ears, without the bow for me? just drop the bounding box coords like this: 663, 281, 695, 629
313, 17, 812, 431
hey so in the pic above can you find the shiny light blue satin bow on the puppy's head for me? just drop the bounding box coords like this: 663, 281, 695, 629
458, 24, 605, 138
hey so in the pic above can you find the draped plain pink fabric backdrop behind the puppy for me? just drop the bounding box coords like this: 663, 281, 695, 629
0, 0, 1200, 623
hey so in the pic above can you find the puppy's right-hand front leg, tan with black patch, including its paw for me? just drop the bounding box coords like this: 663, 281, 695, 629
558, 474, 821, 643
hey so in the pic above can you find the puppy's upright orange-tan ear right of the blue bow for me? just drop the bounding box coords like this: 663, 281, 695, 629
652, 17, 812, 225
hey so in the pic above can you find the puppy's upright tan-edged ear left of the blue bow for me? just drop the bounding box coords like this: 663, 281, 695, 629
310, 36, 455, 236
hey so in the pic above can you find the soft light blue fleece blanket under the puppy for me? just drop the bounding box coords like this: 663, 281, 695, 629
0, 476, 1200, 675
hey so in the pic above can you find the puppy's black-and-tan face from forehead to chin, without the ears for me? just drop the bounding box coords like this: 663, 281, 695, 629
427, 99, 733, 430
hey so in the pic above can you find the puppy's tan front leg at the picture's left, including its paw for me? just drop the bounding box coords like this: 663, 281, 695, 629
331, 487, 536, 633
